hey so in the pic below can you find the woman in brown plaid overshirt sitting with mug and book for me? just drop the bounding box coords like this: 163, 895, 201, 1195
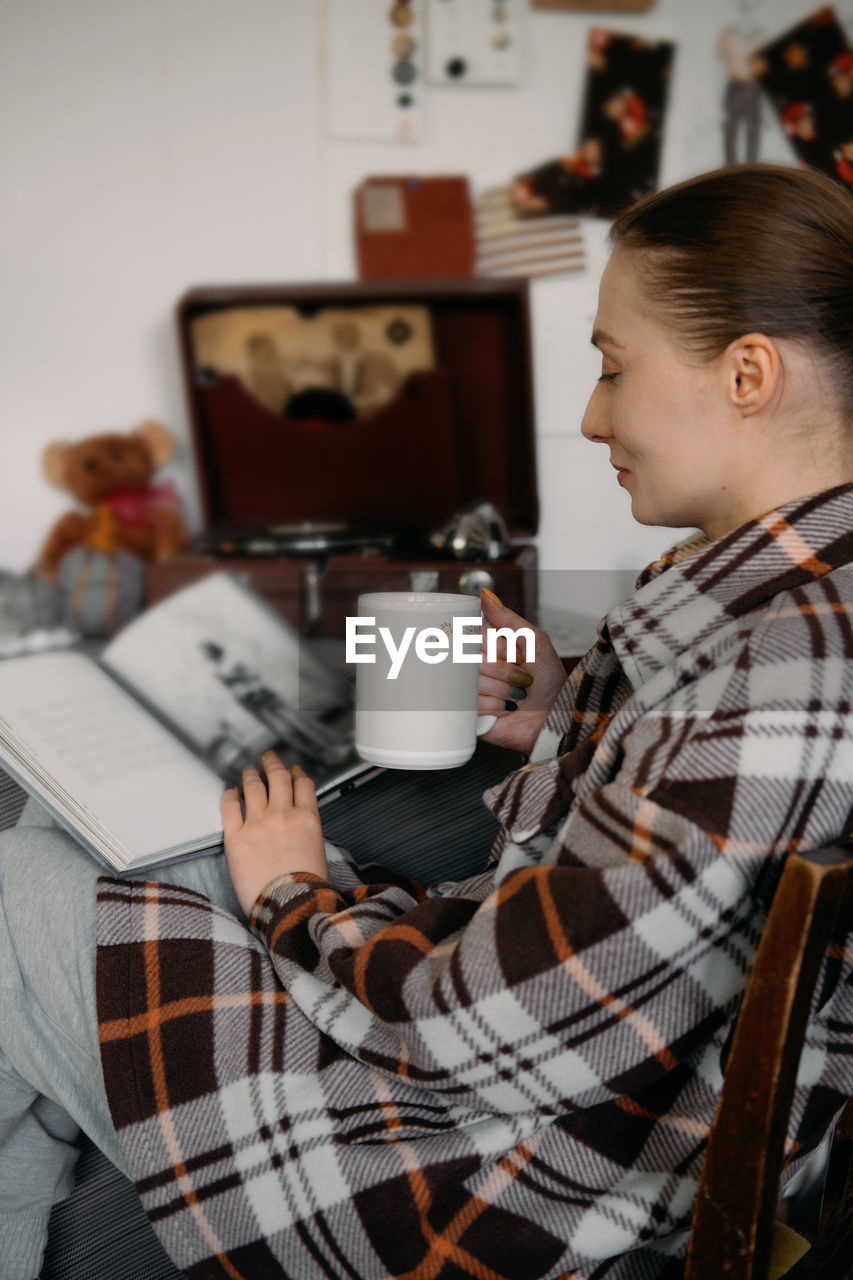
0, 166, 853, 1280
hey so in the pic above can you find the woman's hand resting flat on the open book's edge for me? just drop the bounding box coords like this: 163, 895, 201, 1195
222, 751, 328, 915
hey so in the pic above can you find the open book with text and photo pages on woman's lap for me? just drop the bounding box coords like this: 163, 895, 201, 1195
0, 572, 382, 870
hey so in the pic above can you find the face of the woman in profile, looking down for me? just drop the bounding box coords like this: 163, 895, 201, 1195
581, 250, 749, 538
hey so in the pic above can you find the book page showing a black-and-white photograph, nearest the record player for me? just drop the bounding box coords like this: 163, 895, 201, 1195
101, 571, 352, 777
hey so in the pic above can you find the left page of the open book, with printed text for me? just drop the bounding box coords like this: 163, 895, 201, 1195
0, 653, 222, 865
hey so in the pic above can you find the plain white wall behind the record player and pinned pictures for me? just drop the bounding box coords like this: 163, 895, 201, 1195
0, 0, 853, 614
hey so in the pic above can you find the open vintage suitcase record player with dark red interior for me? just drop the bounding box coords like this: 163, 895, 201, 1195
146, 279, 538, 636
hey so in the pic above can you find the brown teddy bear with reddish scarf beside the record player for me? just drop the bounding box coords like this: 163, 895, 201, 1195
38, 421, 188, 579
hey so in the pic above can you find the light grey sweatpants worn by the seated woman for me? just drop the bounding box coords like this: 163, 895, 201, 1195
0, 803, 245, 1280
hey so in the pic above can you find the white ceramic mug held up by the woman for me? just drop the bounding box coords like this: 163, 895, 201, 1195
347, 591, 483, 769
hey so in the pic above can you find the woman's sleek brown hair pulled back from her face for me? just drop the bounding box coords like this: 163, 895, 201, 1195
610, 164, 853, 413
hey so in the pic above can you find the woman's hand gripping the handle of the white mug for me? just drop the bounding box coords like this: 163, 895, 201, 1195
476, 591, 566, 755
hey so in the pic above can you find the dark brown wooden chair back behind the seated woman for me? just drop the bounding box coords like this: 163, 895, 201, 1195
685, 845, 853, 1280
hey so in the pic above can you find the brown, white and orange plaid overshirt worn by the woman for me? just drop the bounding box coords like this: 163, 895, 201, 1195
97, 486, 853, 1280
